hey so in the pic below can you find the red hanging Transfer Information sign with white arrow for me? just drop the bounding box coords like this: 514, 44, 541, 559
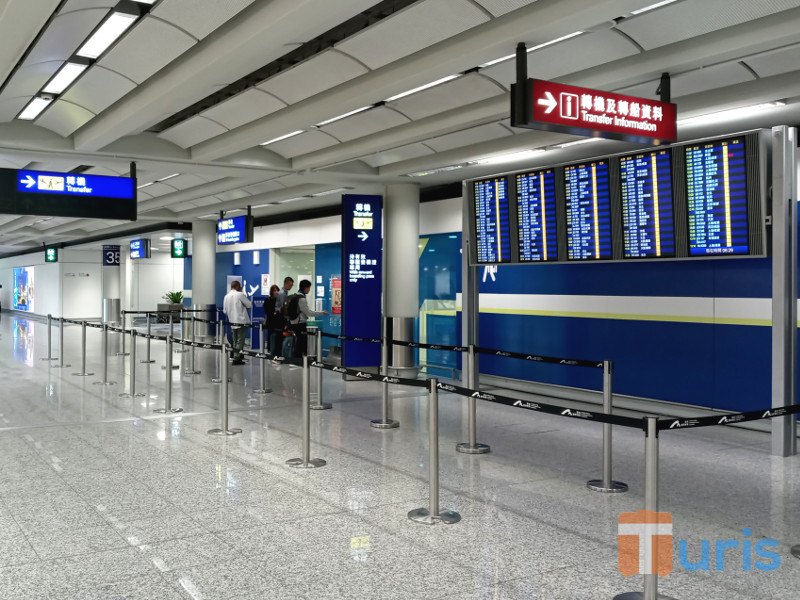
529, 79, 677, 142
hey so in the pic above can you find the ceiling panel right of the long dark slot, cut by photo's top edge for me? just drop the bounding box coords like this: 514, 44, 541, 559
336, 0, 489, 69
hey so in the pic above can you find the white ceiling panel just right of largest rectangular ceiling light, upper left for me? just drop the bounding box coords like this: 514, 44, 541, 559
100, 16, 196, 83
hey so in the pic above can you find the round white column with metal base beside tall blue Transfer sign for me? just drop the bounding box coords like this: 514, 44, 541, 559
383, 183, 419, 377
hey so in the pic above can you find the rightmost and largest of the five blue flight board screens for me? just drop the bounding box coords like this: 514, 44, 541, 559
685, 139, 750, 256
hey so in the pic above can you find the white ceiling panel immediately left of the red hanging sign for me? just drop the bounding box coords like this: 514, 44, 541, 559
390, 73, 505, 119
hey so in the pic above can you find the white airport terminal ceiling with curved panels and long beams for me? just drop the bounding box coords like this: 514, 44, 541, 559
0, 0, 800, 253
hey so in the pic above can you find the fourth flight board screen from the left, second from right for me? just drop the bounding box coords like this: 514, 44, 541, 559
620, 150, 675, 258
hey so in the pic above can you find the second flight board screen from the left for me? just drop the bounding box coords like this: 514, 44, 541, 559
517, 169, 558, 262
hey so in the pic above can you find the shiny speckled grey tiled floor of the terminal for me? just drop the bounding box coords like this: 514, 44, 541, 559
0, 313, 800, 600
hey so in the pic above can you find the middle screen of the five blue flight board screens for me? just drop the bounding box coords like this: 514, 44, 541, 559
564, 160, 611, 260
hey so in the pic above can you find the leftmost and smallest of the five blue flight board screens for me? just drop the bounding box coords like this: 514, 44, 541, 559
473, 177, 511, 263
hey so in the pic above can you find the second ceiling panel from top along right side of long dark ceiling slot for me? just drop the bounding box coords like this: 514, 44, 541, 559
258, 50, 367, 104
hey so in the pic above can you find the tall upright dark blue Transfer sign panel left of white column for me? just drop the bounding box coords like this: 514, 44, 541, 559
342, 194, 383, 367
